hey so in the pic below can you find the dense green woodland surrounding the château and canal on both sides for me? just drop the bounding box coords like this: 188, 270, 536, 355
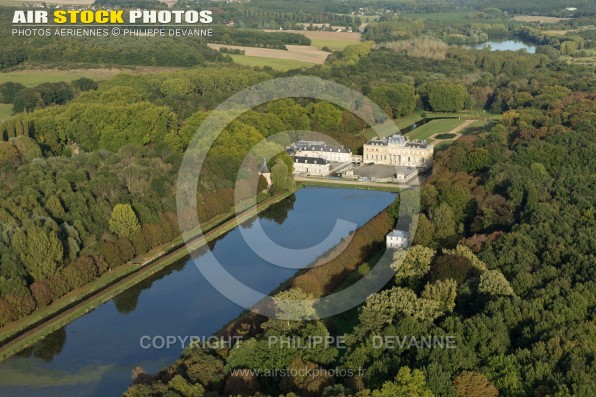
0, 0, 596, 397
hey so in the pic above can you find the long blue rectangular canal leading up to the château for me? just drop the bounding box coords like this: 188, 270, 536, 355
0, 187, 395, 397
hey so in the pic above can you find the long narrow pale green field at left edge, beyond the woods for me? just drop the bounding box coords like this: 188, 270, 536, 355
0, 67, 180, 87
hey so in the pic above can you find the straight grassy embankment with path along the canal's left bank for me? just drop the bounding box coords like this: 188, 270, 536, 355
0, 192, 293, 361
